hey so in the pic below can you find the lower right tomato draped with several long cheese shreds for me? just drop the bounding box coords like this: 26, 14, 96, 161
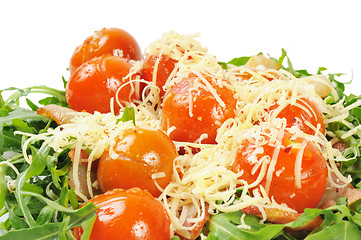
232, 128, 328, 213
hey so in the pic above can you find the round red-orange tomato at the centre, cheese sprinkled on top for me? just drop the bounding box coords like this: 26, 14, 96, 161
161, 77, 236, 144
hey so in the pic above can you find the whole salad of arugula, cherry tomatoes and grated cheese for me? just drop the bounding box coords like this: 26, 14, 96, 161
0, 28, 361, 240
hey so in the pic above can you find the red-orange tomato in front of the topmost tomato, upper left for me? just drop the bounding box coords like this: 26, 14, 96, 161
66, 55, 140, 113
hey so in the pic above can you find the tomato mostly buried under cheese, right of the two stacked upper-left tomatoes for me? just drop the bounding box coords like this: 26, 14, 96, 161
141, 55, 177, 97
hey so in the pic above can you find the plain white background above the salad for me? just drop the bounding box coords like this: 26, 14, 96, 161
0, 0, 361, 94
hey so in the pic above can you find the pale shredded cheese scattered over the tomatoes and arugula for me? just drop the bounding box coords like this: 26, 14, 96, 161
17, 32, 361, 237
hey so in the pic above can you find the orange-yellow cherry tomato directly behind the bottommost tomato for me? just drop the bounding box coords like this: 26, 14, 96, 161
97, 127, 178, 197
